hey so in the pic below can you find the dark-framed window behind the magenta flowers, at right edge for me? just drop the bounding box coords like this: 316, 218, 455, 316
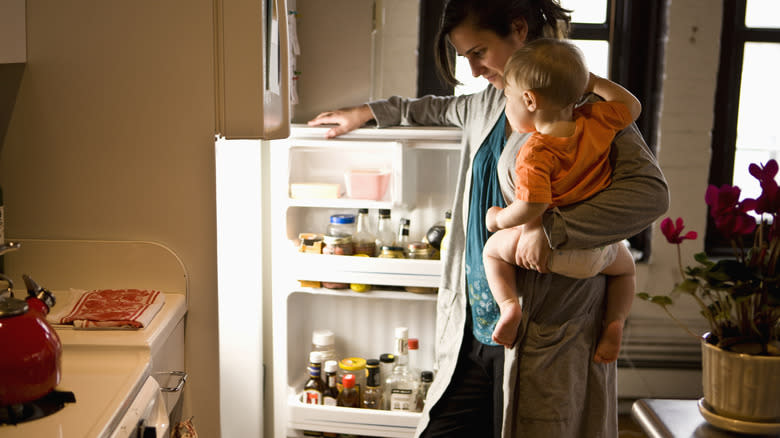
706, 0, 780, 254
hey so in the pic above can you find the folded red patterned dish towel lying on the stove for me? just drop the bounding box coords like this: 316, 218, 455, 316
47, 289, 165, 328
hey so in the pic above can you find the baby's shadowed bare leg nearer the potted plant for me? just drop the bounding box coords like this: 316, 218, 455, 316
593, 244, 635, 363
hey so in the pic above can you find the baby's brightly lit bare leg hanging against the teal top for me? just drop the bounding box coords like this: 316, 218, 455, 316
482, 227, 522, 347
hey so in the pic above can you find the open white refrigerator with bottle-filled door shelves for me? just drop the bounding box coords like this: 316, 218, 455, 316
217, 121, 461, 437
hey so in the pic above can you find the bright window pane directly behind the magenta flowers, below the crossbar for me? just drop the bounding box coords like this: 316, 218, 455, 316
734, 43, 780, 198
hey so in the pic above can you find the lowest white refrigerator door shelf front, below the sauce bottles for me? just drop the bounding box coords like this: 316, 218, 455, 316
288, 395, 421, 438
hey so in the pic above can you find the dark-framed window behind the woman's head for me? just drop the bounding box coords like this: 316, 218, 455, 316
417, 0, 668, 261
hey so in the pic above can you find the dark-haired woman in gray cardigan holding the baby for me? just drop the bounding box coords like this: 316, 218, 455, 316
309, 0, 668, 437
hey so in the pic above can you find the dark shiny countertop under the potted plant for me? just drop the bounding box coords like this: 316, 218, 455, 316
631, 399, 780, 438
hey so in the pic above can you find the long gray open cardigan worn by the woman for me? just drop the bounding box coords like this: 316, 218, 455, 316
369, 86, 669, 437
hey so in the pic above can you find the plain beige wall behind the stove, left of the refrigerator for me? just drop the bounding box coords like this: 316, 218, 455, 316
0, 0, 219, 437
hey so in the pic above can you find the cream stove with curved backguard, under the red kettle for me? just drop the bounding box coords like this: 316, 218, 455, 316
0, 239, 187, 438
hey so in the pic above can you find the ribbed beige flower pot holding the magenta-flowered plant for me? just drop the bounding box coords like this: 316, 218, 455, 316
702, 335, 780, 423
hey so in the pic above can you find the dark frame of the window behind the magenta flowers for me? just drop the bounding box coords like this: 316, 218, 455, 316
705, 0, 780, 256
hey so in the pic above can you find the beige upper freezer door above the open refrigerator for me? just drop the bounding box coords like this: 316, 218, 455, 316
214, 0, 290, 140
